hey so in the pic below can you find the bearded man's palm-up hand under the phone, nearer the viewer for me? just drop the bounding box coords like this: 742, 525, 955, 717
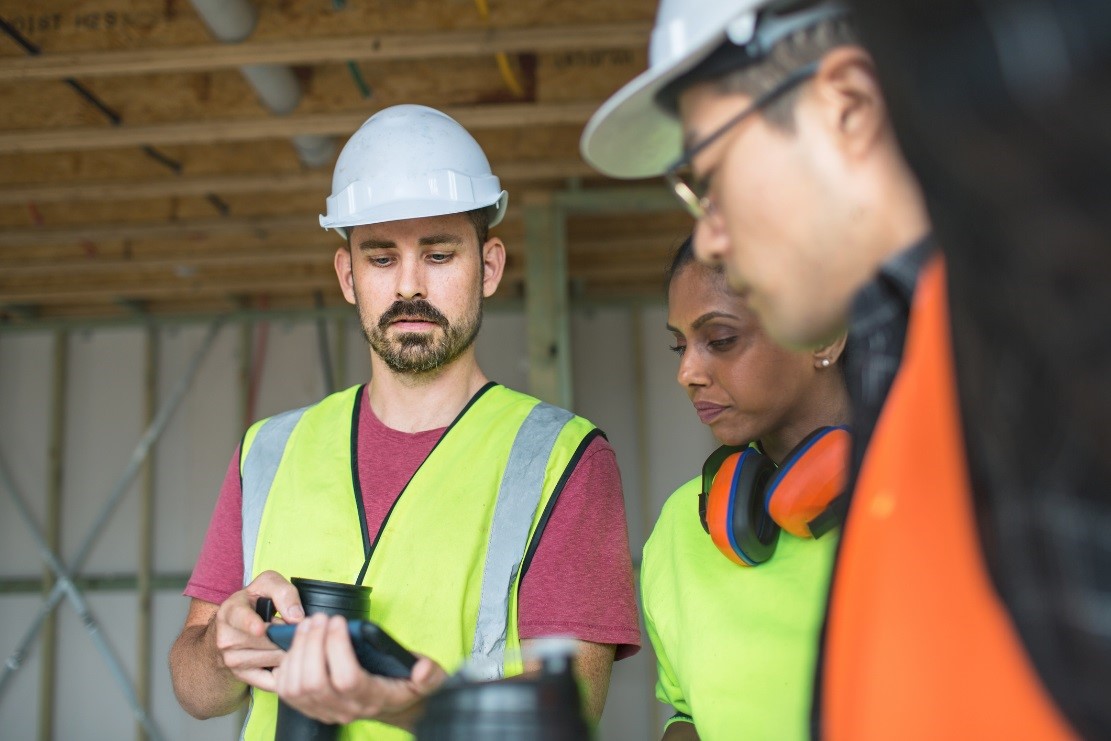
273, 614, 447, 732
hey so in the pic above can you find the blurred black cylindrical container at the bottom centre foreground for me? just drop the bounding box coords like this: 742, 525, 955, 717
417, 661, 591, 741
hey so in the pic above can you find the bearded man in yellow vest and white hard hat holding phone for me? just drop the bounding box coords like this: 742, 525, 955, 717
171, 106, 639, 739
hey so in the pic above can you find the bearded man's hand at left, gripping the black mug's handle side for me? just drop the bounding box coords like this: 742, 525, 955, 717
206, 571, 304, 692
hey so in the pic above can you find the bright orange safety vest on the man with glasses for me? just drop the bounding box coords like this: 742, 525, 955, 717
821, 257, 1074, 741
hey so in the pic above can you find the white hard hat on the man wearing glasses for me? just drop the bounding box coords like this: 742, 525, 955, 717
580, 0, 845, 178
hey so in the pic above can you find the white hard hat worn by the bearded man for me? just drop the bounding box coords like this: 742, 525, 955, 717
320, 106, 509, 239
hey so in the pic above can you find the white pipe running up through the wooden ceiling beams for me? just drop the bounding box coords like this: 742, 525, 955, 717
190, 0, 334, 168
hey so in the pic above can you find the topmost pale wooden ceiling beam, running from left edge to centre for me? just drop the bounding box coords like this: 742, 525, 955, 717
0, 22, 651, 81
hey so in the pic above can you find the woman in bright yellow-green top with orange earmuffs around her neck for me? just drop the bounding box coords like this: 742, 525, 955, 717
641, 239, 850, 741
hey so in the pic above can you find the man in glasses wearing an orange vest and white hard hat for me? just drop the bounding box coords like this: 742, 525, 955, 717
582, 0, 1068, 741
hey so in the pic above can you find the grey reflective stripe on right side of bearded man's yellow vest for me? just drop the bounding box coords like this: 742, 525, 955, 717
471, 402, 574, 679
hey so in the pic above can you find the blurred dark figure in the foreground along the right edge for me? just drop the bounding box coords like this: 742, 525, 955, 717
855, 0, 1111, 739
